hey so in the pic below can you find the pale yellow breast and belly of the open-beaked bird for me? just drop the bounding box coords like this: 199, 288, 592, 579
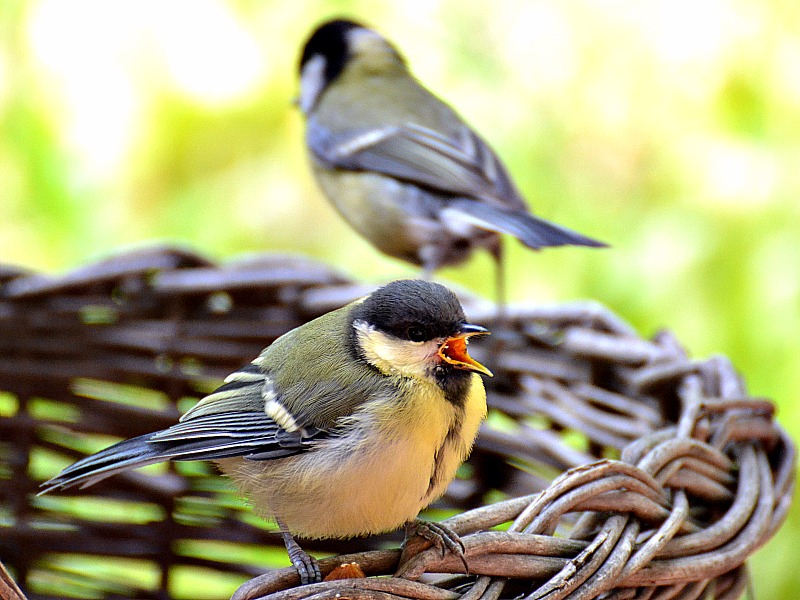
218, 375, 486, 538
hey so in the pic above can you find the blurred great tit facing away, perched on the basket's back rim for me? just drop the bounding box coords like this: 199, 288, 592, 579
298, 20, 605, 305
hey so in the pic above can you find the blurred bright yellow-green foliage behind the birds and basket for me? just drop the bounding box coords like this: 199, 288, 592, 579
0, 0, 800, 598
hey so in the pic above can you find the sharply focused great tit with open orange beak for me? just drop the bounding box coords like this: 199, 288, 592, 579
42, 280, 491, 583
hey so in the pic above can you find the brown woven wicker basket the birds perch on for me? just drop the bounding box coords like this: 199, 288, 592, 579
0, 248, 795, 600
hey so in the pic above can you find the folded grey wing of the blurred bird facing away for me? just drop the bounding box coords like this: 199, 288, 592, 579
306, 118, 525, 209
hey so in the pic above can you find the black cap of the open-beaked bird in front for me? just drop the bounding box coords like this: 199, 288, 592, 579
352, 279, 466, 342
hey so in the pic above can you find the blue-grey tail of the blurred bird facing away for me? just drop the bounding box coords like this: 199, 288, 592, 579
442, 198, 608, 250
